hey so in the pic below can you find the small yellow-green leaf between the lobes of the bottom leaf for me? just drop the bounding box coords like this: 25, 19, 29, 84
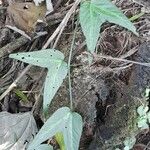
55, 132, 65, 150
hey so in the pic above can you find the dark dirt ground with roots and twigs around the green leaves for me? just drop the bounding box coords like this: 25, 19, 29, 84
0, 0, 150, 150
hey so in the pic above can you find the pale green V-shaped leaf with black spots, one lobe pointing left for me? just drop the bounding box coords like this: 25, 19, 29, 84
9, 49, 68, 112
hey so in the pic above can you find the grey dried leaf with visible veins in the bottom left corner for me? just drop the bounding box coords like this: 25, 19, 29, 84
0, 112, 37, 150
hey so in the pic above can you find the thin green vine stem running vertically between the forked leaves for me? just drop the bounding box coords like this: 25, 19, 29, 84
68, 20, 78, 110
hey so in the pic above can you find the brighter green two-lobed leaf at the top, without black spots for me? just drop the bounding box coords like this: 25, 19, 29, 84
80, 0, 138, 52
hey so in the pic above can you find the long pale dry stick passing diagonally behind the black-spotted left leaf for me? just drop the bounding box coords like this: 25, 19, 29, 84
0, 0, 81, 101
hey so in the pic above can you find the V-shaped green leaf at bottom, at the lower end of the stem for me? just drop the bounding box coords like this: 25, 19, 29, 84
29, 107, 82, 150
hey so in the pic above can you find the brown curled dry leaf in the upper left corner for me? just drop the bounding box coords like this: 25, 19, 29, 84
6, 2, 46, 34
